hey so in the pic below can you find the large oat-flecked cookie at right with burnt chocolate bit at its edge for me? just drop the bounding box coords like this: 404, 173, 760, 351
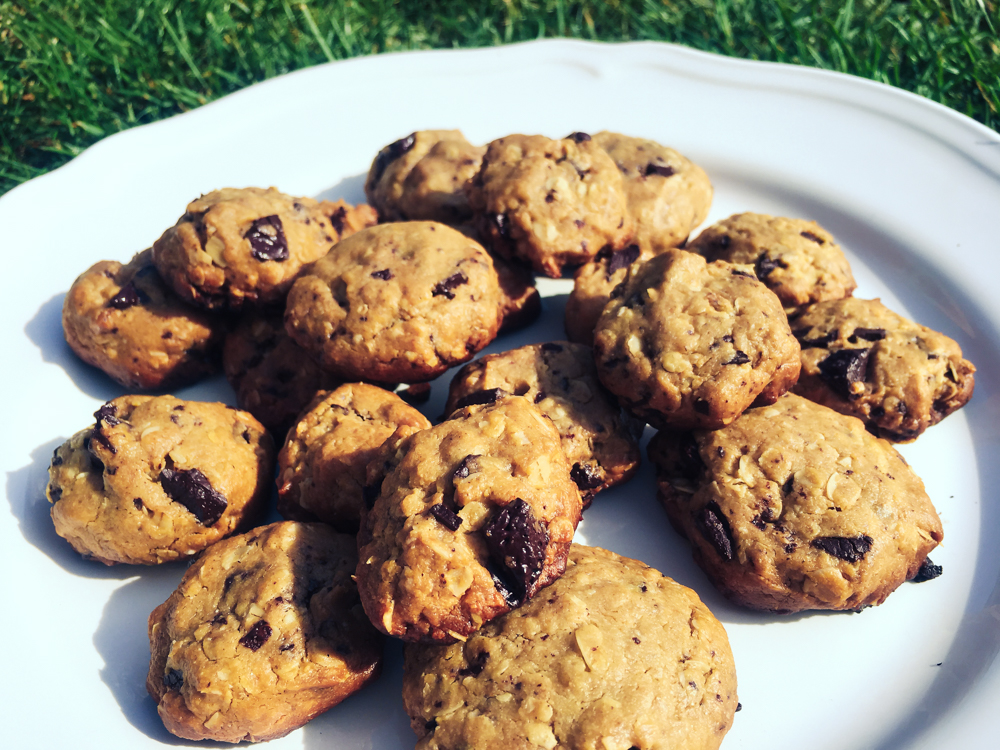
649, 393, 943, 612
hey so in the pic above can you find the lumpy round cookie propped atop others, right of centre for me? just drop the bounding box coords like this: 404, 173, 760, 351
594, 250, 800, 430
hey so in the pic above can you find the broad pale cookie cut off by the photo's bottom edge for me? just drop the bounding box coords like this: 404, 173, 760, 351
403, 544, 738, 750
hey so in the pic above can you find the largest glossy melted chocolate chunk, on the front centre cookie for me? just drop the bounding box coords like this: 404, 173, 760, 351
483, 498, 549, 602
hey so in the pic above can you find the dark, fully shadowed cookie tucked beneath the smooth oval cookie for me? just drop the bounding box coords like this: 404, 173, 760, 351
222, 310, 341, 439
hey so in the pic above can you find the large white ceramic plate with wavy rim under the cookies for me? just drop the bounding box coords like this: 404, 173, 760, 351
0, 41, 1000, 750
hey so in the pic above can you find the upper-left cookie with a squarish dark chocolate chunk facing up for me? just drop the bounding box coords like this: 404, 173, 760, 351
153, 188, 375, 309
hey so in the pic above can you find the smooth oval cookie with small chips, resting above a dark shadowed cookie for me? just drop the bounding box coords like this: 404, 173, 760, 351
285, 221, 501, 383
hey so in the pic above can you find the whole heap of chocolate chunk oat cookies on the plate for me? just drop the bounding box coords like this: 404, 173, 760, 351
47, 130, 975, 750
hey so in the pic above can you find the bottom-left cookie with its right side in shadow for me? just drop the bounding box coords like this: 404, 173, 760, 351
146, 521, 382, 742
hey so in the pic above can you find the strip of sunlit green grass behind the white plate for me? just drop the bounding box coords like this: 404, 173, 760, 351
0, 0, 1000, 194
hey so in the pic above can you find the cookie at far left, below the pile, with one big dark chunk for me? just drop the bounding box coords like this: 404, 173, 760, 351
46, 396, 274, 565
